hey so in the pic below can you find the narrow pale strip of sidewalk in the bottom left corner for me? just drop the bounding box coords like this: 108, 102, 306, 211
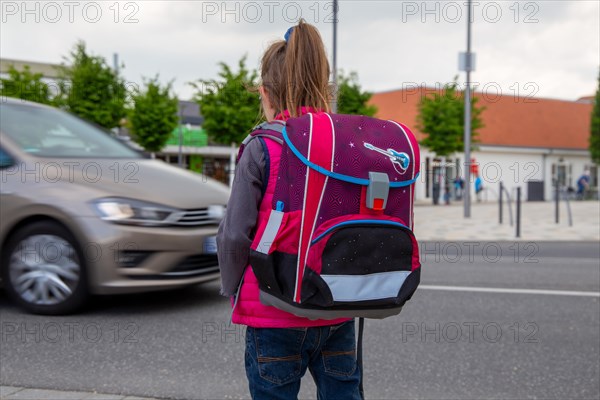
0, 386, 156, 400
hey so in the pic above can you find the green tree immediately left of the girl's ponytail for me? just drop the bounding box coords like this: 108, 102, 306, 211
191, 56, 260, 144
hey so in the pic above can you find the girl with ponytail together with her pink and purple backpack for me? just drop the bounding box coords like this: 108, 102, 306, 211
217, 21, 421, 400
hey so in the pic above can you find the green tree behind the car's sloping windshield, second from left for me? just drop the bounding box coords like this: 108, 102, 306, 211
59, 42, 126, 129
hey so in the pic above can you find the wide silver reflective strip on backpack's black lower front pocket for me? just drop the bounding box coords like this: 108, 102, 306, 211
321, 271, 411, 301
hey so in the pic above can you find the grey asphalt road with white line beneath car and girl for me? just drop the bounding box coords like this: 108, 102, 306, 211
0, 242, 600, 399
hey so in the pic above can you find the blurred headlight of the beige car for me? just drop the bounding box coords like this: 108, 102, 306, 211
93, 198, 178, 226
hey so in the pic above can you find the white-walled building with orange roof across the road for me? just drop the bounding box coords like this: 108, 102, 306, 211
370, 85, 598, 200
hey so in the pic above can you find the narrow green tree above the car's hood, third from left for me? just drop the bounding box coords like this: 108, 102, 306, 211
128, 77, 179, 152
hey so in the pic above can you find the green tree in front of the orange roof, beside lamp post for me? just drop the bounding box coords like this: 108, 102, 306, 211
417, 78, 485, 157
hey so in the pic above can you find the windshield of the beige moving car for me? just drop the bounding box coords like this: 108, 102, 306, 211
0, 103, 142, 158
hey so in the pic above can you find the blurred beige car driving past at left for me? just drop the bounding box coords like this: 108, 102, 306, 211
0, 99, 229, 314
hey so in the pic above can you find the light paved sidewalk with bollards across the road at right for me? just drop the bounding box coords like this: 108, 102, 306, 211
414, 201, 600, 241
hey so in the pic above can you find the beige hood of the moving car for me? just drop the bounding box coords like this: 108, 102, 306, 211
42, 159, 229, 210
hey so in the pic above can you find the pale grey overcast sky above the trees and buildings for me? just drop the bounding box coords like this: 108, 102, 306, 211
0, 0, 600, 100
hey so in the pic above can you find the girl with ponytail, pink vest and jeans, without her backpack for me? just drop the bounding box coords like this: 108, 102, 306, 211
217, 21, 361, 400
